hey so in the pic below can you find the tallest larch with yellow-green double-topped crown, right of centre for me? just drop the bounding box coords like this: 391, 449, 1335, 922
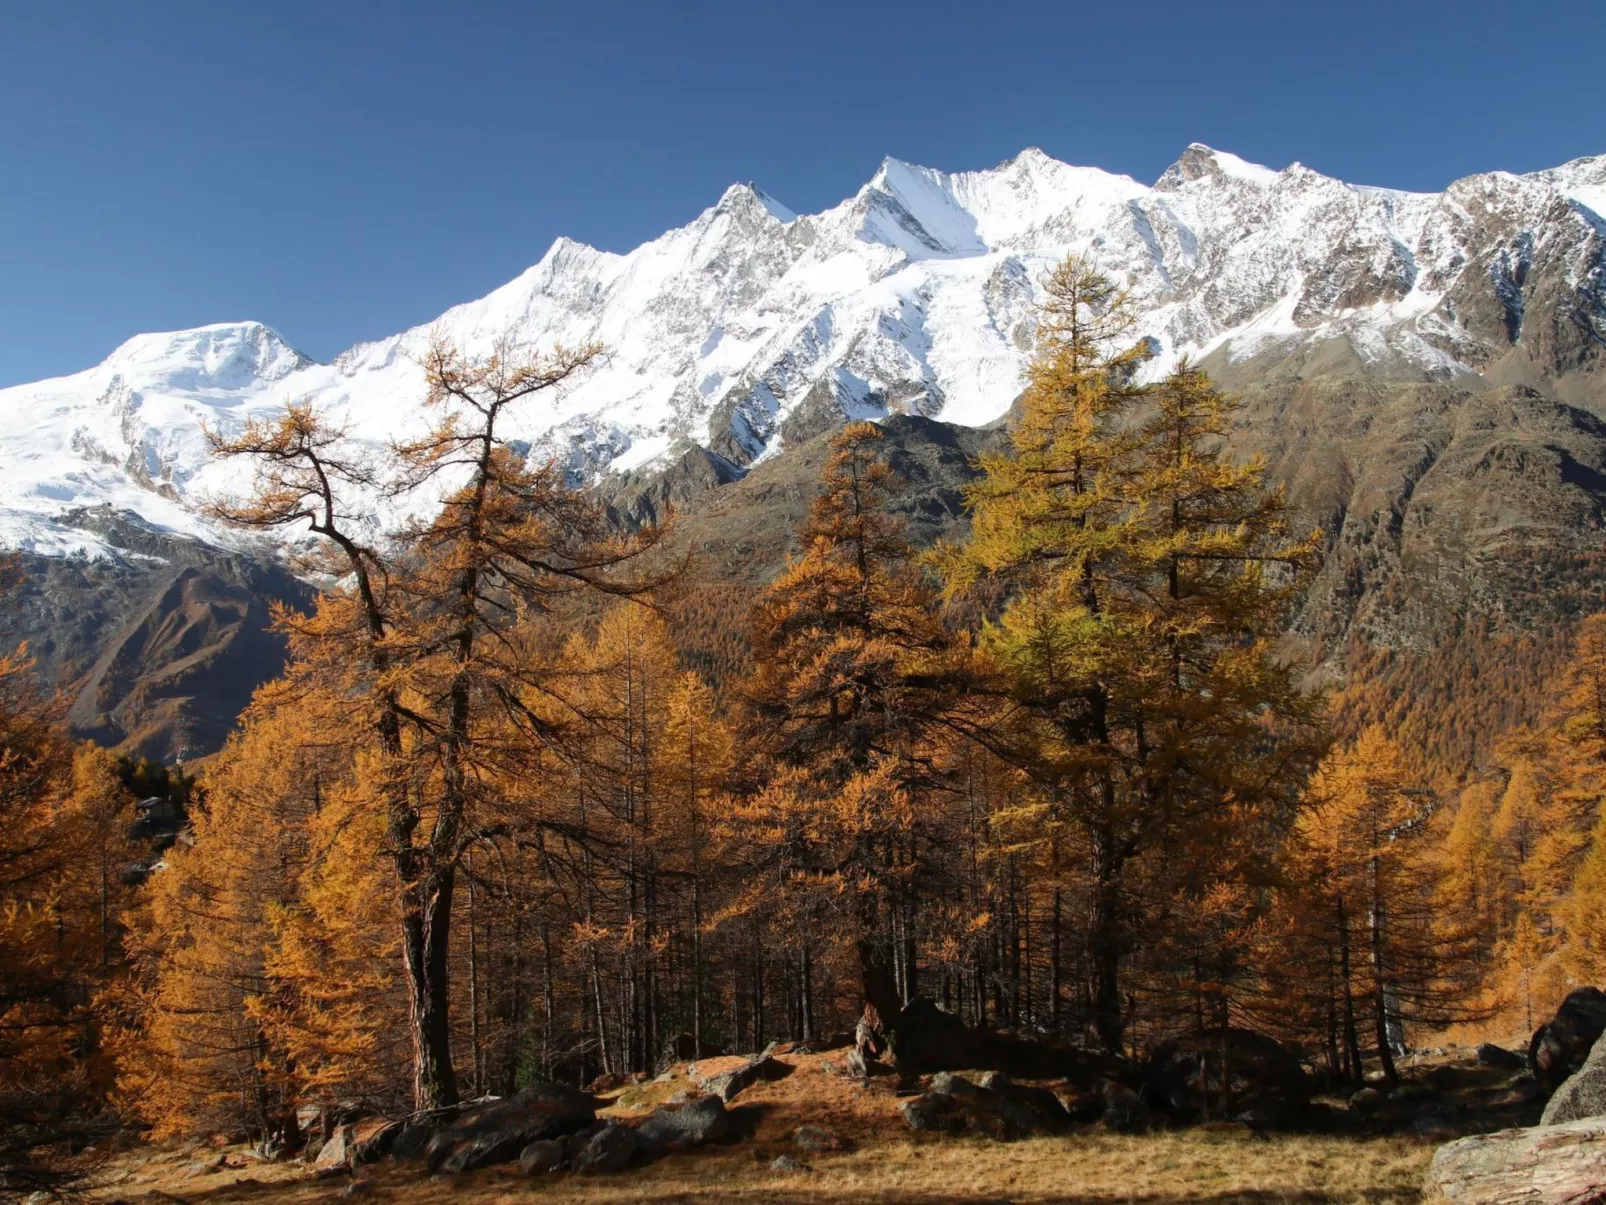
943, 257, 1315, 1049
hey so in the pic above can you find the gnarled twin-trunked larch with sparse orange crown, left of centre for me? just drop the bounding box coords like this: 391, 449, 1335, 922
214, 341, 655, 1109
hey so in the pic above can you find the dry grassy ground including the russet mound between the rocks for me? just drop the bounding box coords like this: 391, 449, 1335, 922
78, 1049, 1531, 1205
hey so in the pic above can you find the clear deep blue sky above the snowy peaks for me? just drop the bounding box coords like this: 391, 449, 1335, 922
0, 0, 1606, 384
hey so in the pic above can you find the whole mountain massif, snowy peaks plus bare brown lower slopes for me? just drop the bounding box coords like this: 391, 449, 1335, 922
0, 145, 1606, 752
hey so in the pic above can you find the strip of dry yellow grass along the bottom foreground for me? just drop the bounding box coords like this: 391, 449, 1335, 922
81, 1131, 1433, 1205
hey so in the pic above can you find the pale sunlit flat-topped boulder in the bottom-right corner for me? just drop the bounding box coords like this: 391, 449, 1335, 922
1428, 1117, 1606, 1205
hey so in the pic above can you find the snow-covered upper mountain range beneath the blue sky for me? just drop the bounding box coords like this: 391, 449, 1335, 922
0, 145, 1606, 553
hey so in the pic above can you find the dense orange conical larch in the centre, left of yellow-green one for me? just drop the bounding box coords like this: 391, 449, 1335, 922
726, 423, 951, 1036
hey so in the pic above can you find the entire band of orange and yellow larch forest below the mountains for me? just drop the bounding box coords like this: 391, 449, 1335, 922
0, 259, 1606, 1182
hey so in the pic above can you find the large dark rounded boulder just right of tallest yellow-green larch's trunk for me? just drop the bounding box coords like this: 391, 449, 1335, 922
1143, 1027, 1310, 1121
